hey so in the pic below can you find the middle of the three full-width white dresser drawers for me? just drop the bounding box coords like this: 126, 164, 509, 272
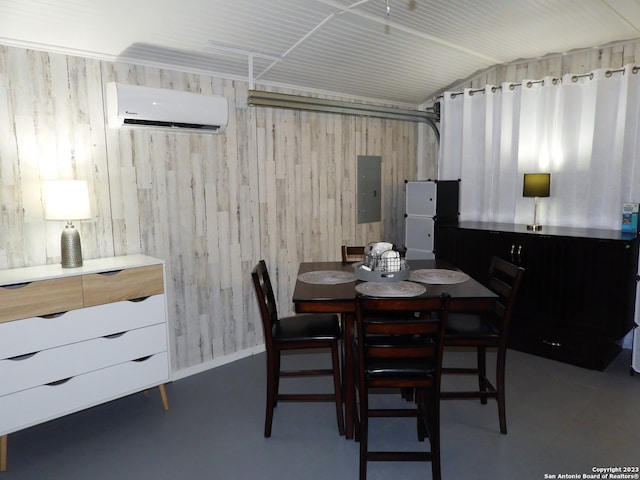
0, 324, 167, 396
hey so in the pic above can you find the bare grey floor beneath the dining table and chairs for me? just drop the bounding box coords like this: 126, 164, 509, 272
0, 350, 640, 480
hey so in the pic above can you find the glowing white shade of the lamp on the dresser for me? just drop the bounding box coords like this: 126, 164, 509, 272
45, 180, 91, 220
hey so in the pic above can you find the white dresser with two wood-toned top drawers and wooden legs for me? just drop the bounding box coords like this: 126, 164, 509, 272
0, 255, 170, 471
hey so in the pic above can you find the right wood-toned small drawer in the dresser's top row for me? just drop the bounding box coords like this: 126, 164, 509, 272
82, 265, 164, 307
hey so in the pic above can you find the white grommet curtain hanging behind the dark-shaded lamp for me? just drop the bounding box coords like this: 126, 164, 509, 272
438, 66, 640, 229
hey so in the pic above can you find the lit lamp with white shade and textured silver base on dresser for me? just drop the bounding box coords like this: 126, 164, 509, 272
45, 180, 91, 268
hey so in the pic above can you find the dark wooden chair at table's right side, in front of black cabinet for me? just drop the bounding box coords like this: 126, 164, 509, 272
440, 257, 524, 434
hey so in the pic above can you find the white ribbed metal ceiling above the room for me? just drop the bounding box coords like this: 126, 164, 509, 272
0, 0, 640, 105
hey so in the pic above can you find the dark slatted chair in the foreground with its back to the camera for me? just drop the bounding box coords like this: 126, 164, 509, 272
354, 294, 449, 480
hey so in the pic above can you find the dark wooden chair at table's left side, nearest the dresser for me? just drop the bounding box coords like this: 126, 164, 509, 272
251, 260, 345, 437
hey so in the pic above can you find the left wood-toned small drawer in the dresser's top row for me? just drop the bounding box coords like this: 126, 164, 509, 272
0, 276, 83, 322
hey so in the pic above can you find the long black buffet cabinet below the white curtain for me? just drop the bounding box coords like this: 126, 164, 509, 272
435, 221, 638, 370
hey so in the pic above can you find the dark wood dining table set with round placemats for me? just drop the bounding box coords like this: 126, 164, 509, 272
293, 260, 496, 438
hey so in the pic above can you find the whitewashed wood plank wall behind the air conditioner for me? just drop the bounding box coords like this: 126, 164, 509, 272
0, 47, 420, 372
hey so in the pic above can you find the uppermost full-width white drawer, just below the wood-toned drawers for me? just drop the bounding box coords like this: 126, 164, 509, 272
0, 295, 166, 359
